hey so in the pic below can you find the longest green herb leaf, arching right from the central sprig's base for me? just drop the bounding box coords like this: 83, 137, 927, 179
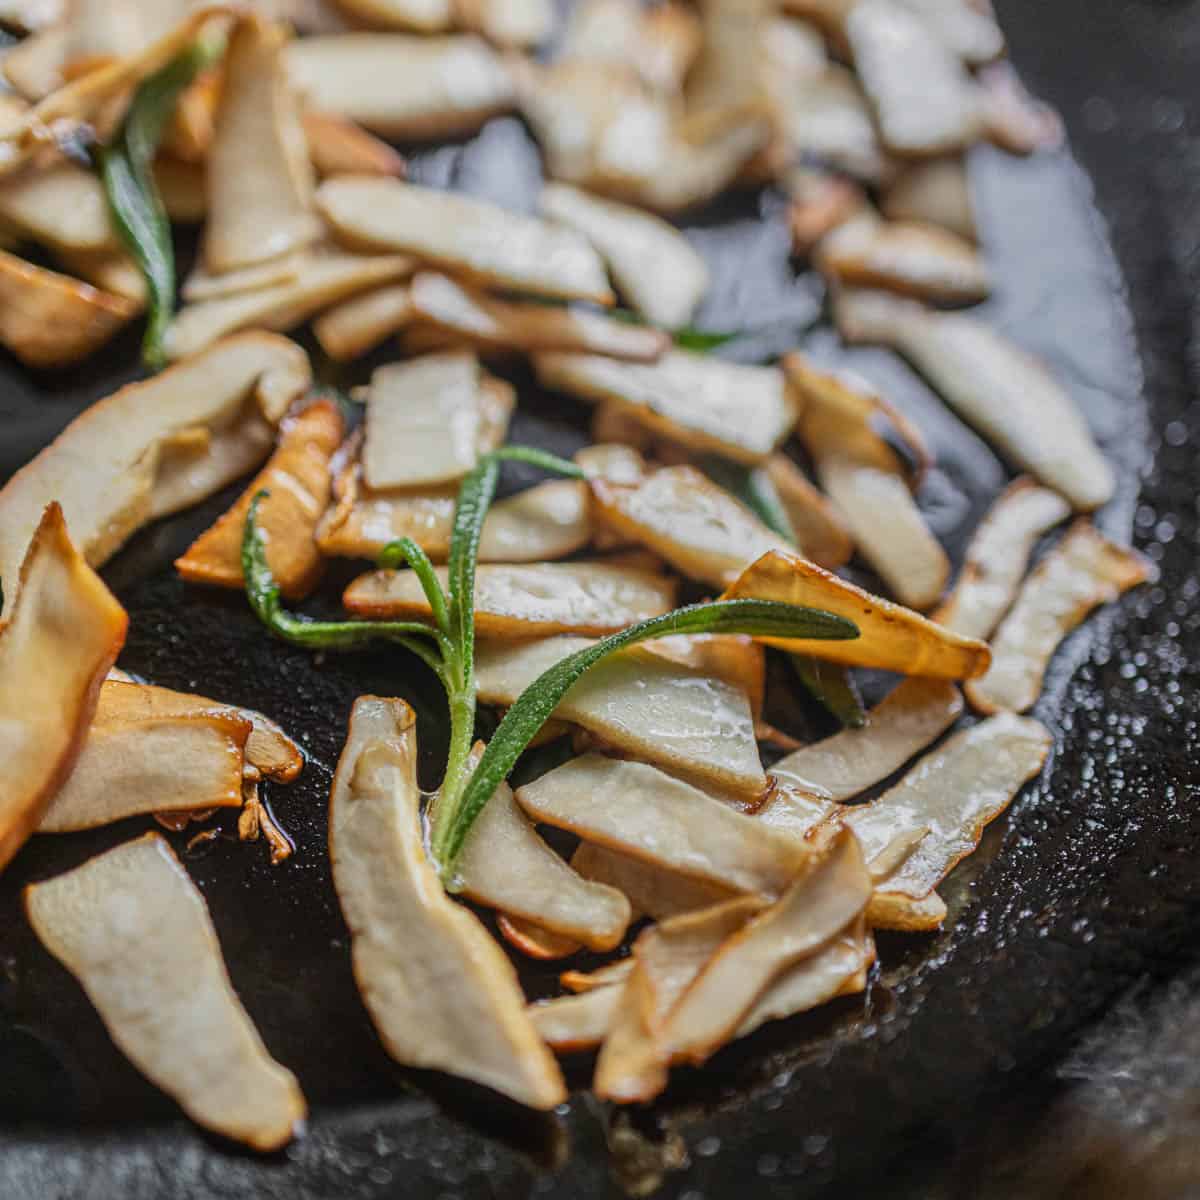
432, 600, 858, 886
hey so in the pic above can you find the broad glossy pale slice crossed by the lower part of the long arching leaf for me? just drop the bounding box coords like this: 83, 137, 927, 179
487, 636, 767, 800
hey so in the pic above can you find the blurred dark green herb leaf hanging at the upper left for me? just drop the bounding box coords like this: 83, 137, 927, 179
100, 42, 223, 368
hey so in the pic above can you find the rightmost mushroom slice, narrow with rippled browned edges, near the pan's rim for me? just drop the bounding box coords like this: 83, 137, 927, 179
967, 521, 1151, 713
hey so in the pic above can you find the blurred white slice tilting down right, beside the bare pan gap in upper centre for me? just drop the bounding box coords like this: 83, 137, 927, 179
541, 184, 709, 329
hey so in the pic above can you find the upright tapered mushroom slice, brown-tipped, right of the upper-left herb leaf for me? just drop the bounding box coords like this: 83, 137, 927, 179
204, 16, 322, 274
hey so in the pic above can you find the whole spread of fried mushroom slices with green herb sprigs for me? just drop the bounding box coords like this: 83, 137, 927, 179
0, 0, 1150, 1150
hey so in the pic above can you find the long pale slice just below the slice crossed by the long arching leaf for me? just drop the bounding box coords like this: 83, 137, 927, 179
517, 754, 811, 895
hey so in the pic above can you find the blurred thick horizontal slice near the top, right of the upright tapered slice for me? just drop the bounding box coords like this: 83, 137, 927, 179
288, 34, 515, 138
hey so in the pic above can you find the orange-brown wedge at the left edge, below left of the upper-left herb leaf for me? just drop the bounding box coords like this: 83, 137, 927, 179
0, 250, 138, 367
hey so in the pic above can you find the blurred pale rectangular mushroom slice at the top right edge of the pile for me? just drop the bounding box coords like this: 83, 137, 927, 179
846, 0, 979, 156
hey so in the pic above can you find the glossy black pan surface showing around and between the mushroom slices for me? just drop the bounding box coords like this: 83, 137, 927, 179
0, 0, 1200, 1200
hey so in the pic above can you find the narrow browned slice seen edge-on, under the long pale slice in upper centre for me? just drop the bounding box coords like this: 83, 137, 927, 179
412, 271, 671, 362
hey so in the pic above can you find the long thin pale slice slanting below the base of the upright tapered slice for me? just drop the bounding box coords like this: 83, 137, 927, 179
164, 248, 413, 359
